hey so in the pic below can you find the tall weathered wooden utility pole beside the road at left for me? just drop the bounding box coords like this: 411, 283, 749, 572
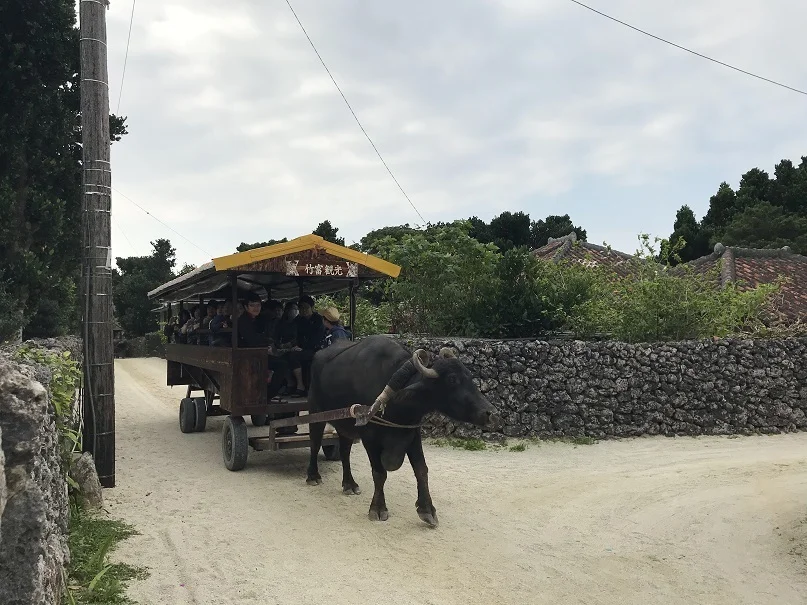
79, 0, 115, 487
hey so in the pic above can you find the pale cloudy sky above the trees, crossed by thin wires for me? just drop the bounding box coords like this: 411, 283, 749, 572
99, 0, 807, 264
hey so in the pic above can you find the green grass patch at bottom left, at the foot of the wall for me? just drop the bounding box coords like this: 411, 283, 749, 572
63, 506, 146, 605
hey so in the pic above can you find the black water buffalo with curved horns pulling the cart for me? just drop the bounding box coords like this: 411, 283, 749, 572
307, 336, 495, 527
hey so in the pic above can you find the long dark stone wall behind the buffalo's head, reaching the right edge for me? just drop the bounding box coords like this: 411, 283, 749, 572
392, 337, 807, 438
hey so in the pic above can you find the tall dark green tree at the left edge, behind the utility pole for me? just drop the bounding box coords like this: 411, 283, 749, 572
0, 0, 126, 340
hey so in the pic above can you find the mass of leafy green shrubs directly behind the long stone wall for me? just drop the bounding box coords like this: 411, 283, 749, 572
366, 222, 781, 342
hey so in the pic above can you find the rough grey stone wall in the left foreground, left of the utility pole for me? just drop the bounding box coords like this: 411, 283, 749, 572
0, 341, 76, 605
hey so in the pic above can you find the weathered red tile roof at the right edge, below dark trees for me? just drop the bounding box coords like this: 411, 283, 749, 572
687, 244, 807, 321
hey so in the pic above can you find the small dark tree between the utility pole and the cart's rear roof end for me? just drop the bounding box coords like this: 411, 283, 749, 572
112, 239, 177, 336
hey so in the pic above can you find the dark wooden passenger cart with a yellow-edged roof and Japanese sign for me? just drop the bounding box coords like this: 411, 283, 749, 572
149, 235, 400, 471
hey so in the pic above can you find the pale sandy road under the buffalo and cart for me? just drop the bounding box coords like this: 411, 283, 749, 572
106, 359, 807, 605
